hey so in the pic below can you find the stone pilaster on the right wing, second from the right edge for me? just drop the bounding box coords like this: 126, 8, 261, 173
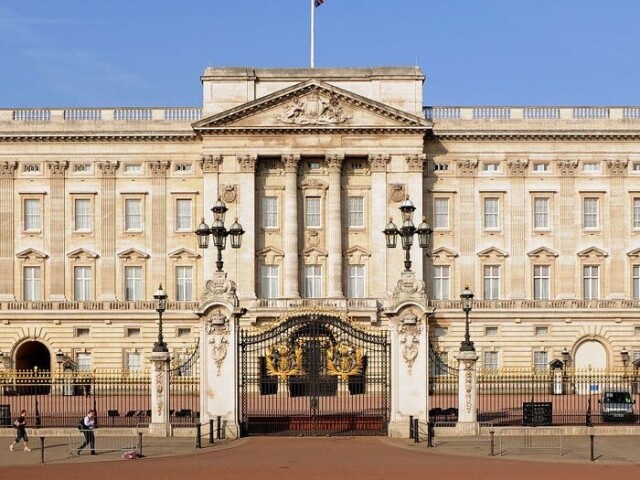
554, 160, 582, 299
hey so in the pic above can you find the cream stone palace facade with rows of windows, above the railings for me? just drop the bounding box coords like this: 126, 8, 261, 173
0, 68, 640, 376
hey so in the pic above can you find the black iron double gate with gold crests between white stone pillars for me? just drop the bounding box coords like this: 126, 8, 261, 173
239, 313, 390, 436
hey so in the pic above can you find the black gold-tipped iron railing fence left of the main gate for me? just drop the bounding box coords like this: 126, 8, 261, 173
0, 370, 200, 428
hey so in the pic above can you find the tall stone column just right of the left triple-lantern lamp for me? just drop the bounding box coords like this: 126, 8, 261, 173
236, 155, 258, 300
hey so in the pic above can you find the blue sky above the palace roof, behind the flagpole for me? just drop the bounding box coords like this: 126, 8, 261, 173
0, 0, 640, 107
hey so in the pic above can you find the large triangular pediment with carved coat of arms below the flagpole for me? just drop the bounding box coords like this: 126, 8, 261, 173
192, 79, 430, 134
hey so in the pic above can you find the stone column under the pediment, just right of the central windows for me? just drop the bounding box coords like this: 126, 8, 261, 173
325, 155, 344, 298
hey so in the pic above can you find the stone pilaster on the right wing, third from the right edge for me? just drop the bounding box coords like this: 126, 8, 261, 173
504, 160, 530, 298
